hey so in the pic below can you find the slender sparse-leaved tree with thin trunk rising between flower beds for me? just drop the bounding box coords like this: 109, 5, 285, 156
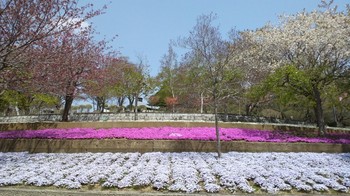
179, 14, 239, 157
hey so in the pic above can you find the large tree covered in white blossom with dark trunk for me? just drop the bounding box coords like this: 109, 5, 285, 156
245, 9, 350, 135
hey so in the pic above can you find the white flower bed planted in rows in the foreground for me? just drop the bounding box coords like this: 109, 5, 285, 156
0, 152, 350, 193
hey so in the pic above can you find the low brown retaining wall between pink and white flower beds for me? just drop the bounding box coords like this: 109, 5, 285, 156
0, 139, 350, 153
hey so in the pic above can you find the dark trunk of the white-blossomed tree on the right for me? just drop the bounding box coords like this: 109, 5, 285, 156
313, 87, 326, 136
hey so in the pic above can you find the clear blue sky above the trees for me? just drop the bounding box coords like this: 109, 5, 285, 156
80, 0, 349, 76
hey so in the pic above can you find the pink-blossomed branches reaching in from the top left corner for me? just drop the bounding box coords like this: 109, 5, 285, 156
0, 0, 104, 94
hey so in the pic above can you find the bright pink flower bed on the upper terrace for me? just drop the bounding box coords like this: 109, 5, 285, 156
0, 127, 350, 144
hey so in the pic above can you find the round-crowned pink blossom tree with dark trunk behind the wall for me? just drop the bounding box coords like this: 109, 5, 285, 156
28, 28, 106, 121
